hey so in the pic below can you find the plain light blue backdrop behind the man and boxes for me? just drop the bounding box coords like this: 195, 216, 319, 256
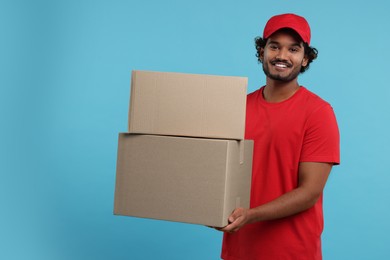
0, 0, 390, 260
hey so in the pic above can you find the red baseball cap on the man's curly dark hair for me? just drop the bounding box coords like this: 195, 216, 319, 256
263, 14, 311, 45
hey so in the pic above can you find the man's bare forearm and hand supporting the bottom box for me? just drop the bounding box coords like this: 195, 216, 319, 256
219, 162, 332, 232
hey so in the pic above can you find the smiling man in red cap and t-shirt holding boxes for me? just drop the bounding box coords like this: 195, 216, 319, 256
221, 14, 339, 260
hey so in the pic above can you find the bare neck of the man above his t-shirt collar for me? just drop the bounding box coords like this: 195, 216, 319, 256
263, 78, 299, 103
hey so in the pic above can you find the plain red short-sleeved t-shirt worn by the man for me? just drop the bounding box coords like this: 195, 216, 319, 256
222, 87, 340, 260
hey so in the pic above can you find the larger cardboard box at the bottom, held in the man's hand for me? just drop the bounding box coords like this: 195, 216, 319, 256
114, 133, 253, 227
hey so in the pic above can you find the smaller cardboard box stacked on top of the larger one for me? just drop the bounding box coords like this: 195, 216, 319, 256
128, 71, 248, 140
